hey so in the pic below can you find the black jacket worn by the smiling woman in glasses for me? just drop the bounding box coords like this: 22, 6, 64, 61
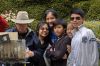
29, 33, 49, 66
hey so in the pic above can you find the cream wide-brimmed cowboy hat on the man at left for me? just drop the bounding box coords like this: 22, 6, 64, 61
11, 11, 34, 24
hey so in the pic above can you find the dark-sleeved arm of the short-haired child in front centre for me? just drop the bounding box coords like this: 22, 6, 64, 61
51, 37, 71, 60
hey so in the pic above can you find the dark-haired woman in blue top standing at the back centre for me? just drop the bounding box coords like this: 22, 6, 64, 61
43, 9, 59, 44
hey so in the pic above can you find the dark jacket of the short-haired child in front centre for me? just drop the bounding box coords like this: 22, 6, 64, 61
46, 36, 71, 66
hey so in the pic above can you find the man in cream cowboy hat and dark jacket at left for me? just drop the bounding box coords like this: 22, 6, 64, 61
6, 11, 34, 66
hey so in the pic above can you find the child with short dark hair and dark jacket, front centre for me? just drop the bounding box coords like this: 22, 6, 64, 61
46, 19, 71, 66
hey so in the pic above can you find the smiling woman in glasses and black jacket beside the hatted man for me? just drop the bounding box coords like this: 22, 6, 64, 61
29, 21, 49, 66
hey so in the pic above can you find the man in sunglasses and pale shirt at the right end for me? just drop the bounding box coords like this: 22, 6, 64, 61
67, 8, 99, 66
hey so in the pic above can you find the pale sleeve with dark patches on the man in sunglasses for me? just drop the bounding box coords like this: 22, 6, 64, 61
78, 30, 99, 66
